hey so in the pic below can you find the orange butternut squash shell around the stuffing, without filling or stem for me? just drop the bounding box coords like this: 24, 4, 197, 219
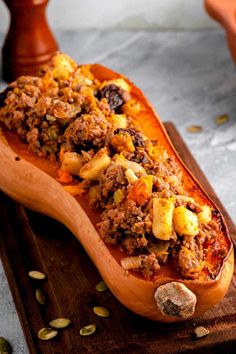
0, 64, 234, 322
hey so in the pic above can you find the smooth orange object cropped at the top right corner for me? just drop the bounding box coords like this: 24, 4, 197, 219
205, 0, 236, 62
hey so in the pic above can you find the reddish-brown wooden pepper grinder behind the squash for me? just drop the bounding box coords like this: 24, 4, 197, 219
2, 0, 58, 82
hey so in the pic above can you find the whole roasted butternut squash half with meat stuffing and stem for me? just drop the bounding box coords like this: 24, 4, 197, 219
0, 53, 233, 322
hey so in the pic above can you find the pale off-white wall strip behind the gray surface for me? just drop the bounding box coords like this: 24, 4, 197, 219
0, 0, 218, 31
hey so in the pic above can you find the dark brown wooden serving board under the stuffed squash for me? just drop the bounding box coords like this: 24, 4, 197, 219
0, 123, 236, 354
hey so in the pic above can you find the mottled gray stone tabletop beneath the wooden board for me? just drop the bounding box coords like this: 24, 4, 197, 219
0, 30, 236, 354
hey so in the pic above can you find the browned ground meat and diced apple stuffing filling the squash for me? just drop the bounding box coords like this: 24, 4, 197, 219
0, 54, 227, 280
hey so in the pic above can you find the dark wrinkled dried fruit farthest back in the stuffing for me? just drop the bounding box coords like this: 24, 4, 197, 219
101, 84, 125, 111
